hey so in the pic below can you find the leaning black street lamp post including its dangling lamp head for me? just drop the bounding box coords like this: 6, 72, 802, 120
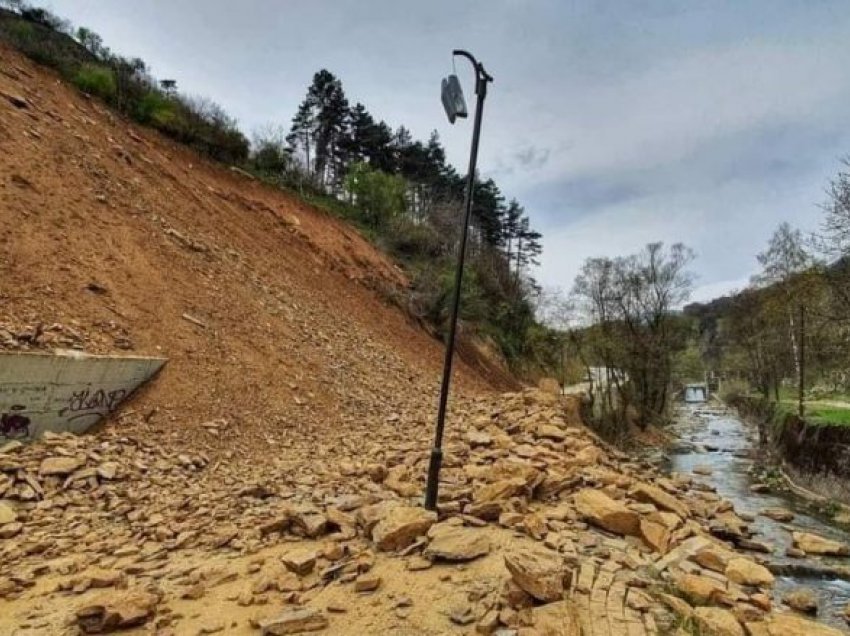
425, 50, 493, 510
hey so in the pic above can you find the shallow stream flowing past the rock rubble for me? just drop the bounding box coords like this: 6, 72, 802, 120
663, 403, 850, 631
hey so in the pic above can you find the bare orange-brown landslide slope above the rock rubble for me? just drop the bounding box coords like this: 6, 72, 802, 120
0, 47, 500, 453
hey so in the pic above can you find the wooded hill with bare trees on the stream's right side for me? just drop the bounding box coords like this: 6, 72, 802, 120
685, 229, 850, 400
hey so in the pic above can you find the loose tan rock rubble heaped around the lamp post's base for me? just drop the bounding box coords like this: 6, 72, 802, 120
0, 390, 840, 634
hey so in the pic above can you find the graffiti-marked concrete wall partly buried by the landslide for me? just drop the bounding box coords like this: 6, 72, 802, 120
0, 351, 166, 442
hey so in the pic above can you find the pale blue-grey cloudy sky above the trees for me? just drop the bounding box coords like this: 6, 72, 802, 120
44, 0, 850, 299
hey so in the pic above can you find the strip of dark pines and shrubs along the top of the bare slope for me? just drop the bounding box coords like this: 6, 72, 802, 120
0, 0, 553, 370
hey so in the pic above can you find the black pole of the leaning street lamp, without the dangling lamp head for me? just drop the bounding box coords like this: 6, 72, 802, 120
425, 50, 493, 510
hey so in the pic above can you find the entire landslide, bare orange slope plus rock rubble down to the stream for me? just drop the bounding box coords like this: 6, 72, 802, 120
0, 42, 850, 636
